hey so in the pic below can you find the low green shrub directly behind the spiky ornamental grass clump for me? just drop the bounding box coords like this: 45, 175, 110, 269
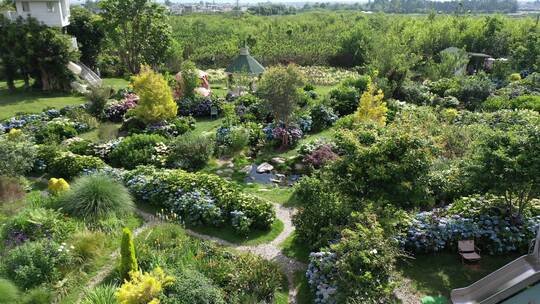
47, 152, 106, 179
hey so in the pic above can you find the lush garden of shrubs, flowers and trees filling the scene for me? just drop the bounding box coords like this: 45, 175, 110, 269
0, 0, 540, 304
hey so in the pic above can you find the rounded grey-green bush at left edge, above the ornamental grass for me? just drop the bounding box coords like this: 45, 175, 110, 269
0, 136, 37, 176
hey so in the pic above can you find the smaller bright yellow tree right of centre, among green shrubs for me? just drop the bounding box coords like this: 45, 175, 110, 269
355, 83, 388, 127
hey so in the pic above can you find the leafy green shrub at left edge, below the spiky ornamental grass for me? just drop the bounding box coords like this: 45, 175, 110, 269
2, 207, 77, 245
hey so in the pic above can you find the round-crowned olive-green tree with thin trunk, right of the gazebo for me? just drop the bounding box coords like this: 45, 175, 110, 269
257, 65, 304, 147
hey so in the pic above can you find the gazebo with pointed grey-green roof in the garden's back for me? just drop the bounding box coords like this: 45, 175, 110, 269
225, 46, 264, 95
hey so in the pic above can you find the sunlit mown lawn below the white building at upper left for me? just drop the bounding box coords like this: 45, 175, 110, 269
0, 78, 128, 119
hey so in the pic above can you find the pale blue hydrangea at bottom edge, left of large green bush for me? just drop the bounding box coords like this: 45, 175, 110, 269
306, 251, 337, 304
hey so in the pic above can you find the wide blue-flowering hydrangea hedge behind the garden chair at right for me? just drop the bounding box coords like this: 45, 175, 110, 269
399, 197, 540, 254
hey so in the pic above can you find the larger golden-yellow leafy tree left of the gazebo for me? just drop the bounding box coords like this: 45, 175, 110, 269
132, 66, 178, 123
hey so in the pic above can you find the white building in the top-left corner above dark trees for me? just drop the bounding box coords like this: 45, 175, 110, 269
5, 0, 69, 27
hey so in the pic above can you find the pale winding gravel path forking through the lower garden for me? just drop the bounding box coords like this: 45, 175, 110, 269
83, 204, 306, 304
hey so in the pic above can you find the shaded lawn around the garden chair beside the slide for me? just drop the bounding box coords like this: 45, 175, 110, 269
398, 253, 519, 299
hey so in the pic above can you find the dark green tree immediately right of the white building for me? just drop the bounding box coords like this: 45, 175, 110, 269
67, 6, 105, 68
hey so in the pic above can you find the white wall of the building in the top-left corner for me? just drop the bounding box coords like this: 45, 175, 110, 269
15, 0, 69, 27
